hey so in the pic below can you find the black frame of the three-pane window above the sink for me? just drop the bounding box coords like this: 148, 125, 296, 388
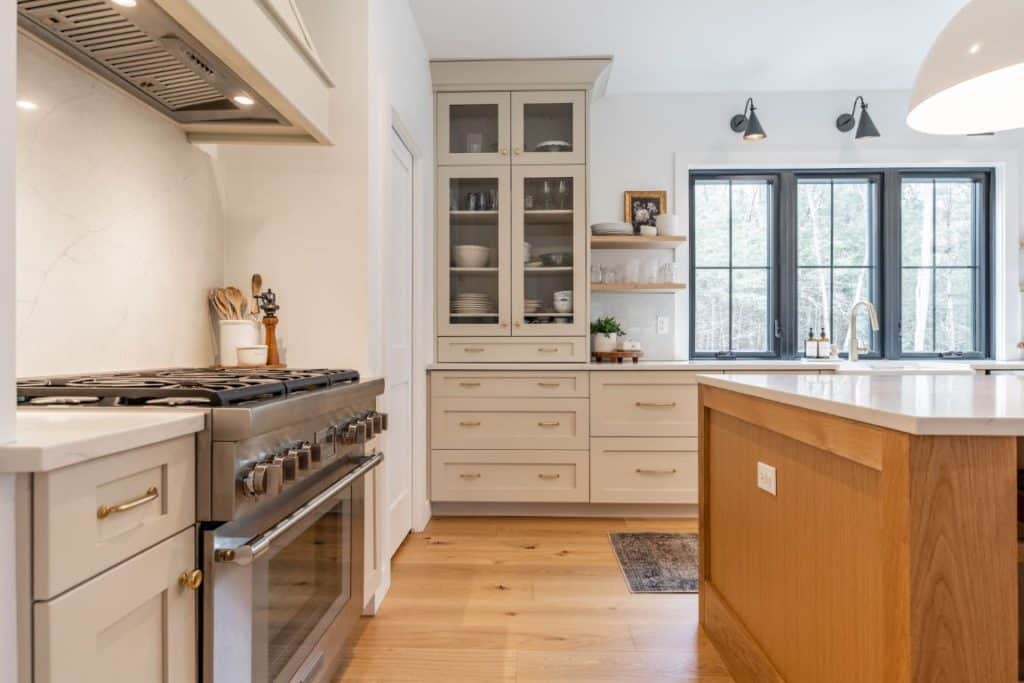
688, 167, 995, 359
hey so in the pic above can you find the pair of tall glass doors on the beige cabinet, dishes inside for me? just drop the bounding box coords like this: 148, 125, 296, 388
437, 166, 588, 337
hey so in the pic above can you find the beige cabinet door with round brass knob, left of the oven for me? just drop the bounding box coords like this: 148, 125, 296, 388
33, 528, 198, 683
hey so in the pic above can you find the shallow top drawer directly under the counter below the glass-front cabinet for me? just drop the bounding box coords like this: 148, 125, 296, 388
430, 371, 589, 398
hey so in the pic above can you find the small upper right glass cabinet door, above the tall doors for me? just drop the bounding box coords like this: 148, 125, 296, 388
512, 91, 587, 164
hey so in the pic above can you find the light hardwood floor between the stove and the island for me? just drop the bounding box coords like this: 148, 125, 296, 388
339, 517, 732, 683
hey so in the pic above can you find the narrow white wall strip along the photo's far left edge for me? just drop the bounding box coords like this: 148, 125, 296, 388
0, 3, 17, 681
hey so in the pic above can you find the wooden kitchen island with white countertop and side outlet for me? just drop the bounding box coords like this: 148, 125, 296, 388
697, 375, 1024, 683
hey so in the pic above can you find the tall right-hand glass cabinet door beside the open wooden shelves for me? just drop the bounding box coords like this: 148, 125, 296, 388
512, 166, 588, 337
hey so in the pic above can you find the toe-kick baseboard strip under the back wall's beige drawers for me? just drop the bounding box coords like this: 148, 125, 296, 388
432, 503, 697, 519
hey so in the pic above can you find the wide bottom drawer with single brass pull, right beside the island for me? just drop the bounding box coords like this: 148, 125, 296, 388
590, 438, 697, 503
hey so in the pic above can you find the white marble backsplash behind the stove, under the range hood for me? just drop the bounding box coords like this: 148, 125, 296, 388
16, 36, 224, 377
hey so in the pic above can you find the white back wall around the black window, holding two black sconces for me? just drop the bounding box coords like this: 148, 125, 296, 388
590, 92, 1024, 357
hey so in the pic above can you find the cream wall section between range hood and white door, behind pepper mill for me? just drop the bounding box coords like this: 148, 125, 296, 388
217, 0, 371, 373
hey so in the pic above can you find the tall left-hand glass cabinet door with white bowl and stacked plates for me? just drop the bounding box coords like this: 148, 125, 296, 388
437, 166, 512, 336
